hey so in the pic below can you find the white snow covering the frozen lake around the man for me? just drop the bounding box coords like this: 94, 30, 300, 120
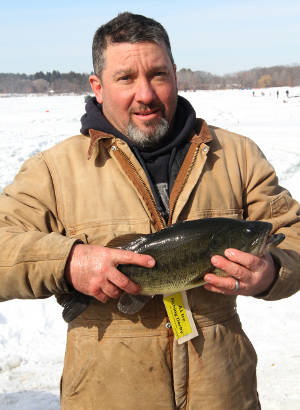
0, 87, 300, 410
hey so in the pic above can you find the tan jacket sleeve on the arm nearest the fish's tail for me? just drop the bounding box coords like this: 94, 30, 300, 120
0, 154, 76, 301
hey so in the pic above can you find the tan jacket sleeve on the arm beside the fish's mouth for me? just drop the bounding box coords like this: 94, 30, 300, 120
245, 139, 300, 300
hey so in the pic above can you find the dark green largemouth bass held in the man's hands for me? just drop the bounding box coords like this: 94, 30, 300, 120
58, 218, 284, 322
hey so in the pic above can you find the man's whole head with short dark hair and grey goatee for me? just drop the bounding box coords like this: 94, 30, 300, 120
90, 13, 177, 146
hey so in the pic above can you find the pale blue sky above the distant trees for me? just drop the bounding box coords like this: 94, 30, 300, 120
0, 0, 300, 75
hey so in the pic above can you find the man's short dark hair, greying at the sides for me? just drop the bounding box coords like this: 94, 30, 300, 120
92, 12, 174, 78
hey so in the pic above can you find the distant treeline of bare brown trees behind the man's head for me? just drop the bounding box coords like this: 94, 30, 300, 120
0, 65, 300, 94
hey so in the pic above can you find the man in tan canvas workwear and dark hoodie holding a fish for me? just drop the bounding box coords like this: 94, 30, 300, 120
0, 13, 300, 410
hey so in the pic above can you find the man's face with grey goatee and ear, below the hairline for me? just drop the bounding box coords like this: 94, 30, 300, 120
90, 42, 177, 146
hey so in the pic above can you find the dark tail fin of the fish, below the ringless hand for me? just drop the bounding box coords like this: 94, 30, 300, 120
56, 291, 91, 323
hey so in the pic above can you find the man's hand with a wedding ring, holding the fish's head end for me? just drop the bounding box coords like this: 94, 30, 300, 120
204, 249, 276, 296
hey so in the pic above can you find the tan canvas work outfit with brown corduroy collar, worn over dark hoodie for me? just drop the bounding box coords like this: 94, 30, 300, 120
0, 120, 300, 410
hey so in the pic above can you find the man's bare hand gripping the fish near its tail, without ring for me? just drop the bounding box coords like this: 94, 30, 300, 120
65, 244, 155, 303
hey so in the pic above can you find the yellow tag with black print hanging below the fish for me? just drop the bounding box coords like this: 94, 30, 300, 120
163, 292, 198, 343
